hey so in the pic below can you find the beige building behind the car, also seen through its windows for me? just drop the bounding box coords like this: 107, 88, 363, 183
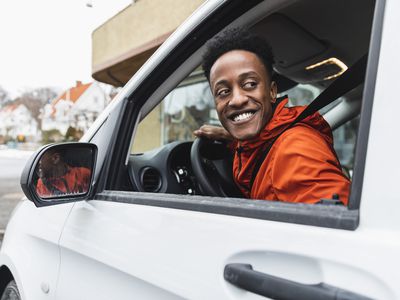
92, 0, 204, 152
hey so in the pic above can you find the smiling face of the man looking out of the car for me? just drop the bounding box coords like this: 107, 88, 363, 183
210, 50, 277, 141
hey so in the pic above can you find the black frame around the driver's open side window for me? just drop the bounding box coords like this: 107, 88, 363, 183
100, 0, 385, 230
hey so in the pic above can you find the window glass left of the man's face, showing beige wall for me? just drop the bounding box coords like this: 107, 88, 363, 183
132, 71, 220, 153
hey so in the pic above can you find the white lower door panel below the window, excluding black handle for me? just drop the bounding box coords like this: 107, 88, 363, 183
58, 198, 398, 299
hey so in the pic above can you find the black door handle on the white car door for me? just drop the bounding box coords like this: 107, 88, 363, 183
224, 264, 371, 300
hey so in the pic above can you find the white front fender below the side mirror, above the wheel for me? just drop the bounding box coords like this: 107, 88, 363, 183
0, 199, 75, 300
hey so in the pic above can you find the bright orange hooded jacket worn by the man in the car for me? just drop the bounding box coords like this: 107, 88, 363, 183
232, 99, 350, 205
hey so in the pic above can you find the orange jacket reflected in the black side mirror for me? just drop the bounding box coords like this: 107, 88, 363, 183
36, 167, 91, 197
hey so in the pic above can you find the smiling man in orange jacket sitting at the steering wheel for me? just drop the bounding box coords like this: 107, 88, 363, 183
194, 29, 350, 205
